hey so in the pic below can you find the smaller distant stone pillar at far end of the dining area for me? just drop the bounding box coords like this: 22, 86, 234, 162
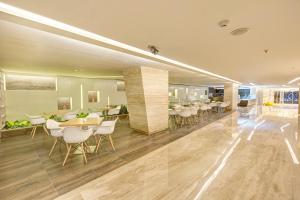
223, 83, 239, 110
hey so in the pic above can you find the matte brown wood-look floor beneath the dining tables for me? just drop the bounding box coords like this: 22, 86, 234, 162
0, 113, 229, 200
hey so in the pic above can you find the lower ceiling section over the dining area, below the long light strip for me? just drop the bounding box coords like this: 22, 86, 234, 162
0, 20, 224, 85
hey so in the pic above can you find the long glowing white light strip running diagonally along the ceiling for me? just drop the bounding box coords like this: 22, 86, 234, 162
0, 2, 241, 84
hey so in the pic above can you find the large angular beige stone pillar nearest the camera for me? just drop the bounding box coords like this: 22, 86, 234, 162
124, 66, 169, 134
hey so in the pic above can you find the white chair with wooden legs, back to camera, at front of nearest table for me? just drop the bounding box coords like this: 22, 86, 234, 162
63, 127, 93, 166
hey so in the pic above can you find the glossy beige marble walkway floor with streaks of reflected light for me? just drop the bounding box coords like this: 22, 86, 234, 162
57, 106, 300, 200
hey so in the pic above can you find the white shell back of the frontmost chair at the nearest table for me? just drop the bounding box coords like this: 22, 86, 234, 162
63, 127, 93, 143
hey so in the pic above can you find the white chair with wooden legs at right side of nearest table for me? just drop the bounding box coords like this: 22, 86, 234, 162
94, 118, 118, 152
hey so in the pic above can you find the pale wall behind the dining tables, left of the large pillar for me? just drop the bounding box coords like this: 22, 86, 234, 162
5, 77, 127, 120
